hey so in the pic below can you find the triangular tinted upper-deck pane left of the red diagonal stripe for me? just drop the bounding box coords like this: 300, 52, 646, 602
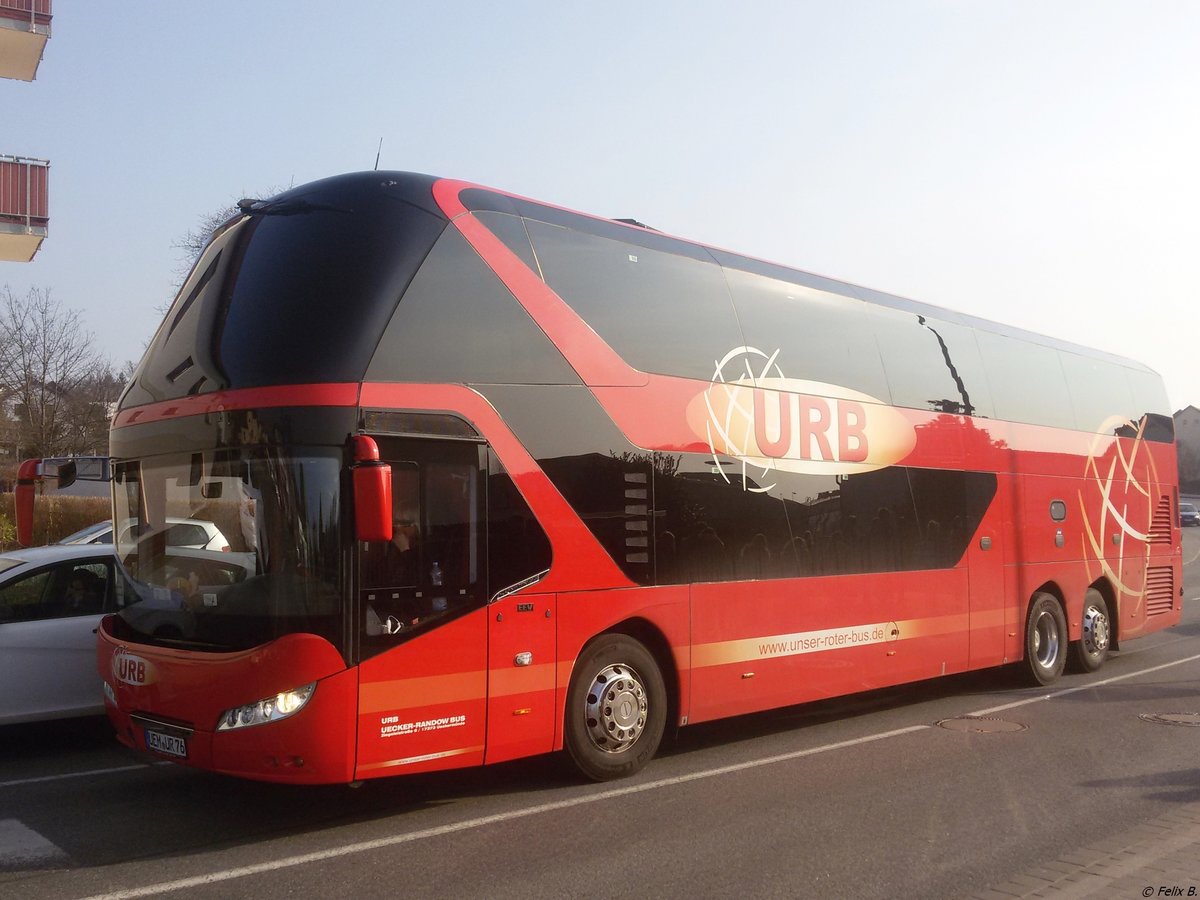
367, 229, 578, 384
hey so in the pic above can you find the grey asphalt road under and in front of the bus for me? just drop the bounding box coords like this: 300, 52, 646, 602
0, 528, 1200, 900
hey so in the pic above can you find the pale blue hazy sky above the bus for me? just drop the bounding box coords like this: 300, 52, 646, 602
0, 0, 1200, 410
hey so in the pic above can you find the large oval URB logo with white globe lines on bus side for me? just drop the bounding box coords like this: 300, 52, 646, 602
688, 347, 917, 492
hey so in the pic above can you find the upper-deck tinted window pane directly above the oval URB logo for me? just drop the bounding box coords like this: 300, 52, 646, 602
718, 269, 889, 402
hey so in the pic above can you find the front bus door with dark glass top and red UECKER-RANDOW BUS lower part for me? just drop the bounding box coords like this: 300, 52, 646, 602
355, 436, 487, 778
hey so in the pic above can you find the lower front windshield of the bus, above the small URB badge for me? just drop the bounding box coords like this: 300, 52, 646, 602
113, 448, 343, 652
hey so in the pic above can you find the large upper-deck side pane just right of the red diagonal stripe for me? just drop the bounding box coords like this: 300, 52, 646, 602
527, 221, 742, 380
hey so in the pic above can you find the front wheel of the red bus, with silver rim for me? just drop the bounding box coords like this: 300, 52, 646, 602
564, 634, 667, 781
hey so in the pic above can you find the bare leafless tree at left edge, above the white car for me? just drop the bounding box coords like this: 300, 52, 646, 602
0, 286, 112, 457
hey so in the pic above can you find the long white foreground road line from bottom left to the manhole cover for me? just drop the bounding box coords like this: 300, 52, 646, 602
88, 725, 931, 900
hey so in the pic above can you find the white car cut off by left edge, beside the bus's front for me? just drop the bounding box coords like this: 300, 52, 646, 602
0, 544, 124, 725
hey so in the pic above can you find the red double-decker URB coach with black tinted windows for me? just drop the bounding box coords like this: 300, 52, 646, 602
98, 172, 1182, 782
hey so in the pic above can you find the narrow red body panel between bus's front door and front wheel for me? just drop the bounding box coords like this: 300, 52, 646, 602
485, 593, 558, 763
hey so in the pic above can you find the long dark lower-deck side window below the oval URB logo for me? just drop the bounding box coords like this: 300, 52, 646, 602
654, 456, 996, 583
